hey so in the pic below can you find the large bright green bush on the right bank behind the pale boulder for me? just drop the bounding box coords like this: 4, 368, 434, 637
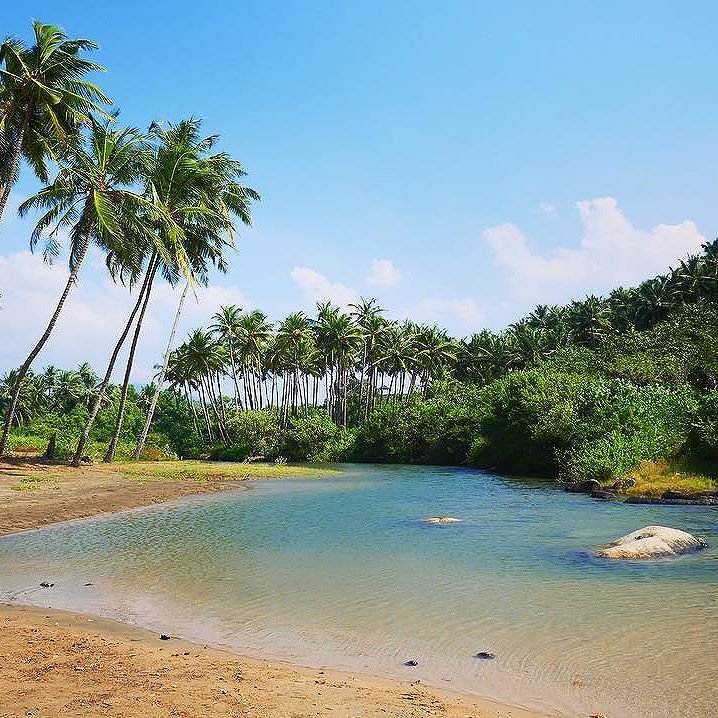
469, 370, 697, 480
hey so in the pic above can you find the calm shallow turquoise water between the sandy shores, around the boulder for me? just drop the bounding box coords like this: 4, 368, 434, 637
0, 465, 718, 718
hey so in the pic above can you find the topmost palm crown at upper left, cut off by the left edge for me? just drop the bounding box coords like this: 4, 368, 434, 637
0, 20, 112, 219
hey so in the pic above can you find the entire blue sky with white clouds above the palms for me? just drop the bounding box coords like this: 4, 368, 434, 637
0, 0, 718, 382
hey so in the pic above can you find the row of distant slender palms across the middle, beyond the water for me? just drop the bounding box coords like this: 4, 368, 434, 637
167, 300, 459, 441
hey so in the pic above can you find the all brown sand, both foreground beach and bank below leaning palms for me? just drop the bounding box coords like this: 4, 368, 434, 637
0, 460, 552, 718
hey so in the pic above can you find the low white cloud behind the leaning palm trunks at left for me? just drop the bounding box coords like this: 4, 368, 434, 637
0, 251, 247, 382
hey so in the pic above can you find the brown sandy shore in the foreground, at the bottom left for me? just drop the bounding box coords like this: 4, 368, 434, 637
0, 605, 552, 718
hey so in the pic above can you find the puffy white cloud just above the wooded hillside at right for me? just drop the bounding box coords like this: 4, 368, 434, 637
484, 197, 705, 303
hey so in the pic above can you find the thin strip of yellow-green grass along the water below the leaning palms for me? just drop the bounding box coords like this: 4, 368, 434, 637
119, 461, 341, 483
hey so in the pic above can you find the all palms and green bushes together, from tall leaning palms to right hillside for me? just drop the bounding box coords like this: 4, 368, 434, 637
0, 21, 718, 494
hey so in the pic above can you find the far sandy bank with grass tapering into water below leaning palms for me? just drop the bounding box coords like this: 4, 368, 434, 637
0, 458, 335, 536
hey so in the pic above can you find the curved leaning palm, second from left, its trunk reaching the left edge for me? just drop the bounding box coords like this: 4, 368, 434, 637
0, 119, 147, 454
